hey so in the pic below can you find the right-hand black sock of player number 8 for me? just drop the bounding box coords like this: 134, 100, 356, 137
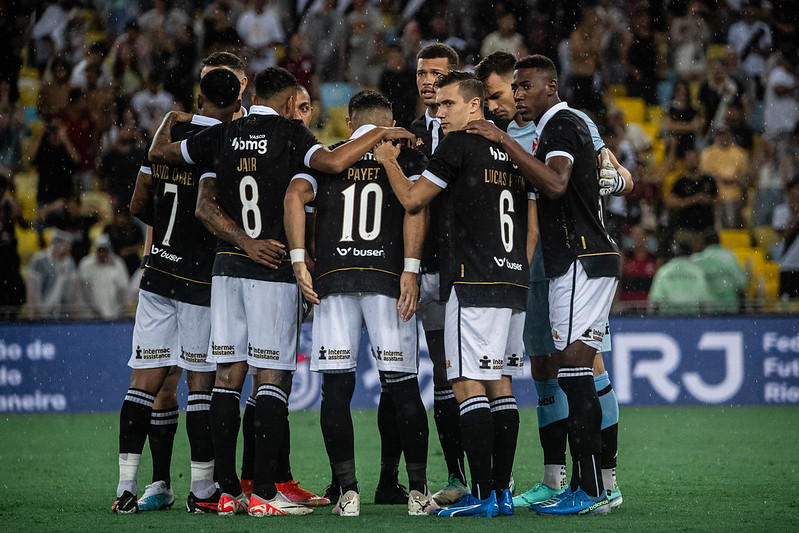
252, 384, 289, 500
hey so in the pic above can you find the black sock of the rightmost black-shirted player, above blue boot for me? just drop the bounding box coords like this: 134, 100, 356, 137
558, 367, 603, 497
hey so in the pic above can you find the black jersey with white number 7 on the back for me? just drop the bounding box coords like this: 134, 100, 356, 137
140, 115, 220, 306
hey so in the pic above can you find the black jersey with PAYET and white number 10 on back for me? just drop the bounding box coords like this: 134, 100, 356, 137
314, 133, 427, 298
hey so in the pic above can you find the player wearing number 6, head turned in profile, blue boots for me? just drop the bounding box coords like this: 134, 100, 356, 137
375, 72, 532, 516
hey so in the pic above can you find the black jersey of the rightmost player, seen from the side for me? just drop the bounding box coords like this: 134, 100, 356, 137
535, 103, 620, 278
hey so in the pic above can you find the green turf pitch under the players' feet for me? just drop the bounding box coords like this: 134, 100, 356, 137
0, 407, 799, 533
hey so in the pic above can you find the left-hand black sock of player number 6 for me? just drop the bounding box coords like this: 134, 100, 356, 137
460, 396, 494, 500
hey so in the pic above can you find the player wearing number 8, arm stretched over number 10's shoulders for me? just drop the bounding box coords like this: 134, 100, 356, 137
150, 68, 413, 516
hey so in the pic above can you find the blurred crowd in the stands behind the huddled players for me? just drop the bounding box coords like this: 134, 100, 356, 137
0, 0, 799, 319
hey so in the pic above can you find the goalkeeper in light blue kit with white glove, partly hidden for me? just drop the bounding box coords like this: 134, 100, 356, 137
468, 51, 633, 508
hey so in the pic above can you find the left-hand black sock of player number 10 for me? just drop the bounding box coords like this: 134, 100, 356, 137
319, 372, 357, 493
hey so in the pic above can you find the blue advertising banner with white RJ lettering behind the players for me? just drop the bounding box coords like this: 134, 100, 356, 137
0, 316, 799, 413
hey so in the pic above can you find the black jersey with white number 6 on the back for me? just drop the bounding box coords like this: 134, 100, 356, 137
422, 131, 532, 310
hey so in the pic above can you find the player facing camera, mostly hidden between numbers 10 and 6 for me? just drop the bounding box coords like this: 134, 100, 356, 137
410, 43, 469, 505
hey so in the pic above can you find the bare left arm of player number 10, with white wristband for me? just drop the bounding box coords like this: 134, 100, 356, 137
283, 174, 319, 304
